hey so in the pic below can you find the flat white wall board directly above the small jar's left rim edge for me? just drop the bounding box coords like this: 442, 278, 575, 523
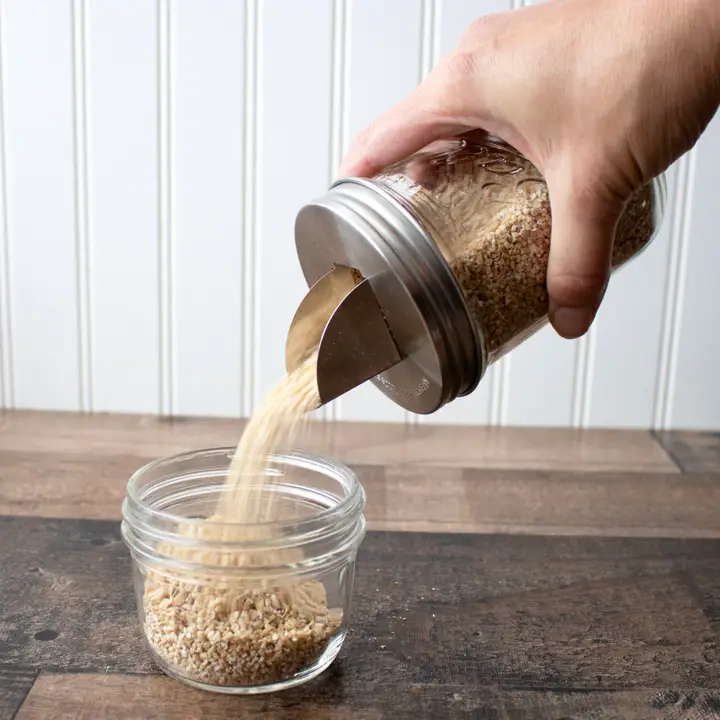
85, 0, 159, 413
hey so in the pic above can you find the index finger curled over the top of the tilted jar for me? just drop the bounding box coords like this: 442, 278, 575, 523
338, 74, 471, 177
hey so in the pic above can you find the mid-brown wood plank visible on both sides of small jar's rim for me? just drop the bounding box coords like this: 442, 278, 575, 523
0, 450, 720, 537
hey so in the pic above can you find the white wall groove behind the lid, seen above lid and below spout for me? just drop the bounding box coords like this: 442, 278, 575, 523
320, 0, 348, 420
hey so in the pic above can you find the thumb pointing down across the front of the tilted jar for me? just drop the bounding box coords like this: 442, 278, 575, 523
547, 167, 625, 339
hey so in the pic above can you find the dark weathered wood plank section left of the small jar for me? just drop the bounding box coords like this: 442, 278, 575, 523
0, 518, 155, 673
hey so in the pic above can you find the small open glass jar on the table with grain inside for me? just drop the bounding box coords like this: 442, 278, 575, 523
122, 448, 365, 694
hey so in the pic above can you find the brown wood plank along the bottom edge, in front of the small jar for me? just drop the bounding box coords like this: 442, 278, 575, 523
17, 673, 720, 720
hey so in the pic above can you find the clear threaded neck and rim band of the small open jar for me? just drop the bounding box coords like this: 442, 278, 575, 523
121, 447, 366, 582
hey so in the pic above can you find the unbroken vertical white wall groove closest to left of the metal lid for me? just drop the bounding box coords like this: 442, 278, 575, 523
242, 0, 262, 416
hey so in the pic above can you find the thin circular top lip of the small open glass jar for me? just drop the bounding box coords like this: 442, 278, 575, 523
122, 447, 365, 530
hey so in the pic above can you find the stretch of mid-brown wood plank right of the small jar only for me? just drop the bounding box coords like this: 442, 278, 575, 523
366, 466, 720, 538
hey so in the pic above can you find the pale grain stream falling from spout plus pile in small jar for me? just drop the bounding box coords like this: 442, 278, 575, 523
143, 354, 343, 687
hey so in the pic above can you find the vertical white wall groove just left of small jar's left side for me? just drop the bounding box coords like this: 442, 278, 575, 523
73, 0, 93, 412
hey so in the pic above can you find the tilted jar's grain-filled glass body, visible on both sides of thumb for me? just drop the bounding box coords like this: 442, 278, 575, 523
374, 131, 665, 366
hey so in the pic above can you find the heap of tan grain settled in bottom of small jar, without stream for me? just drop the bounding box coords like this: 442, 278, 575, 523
144, 578, 343, 687
